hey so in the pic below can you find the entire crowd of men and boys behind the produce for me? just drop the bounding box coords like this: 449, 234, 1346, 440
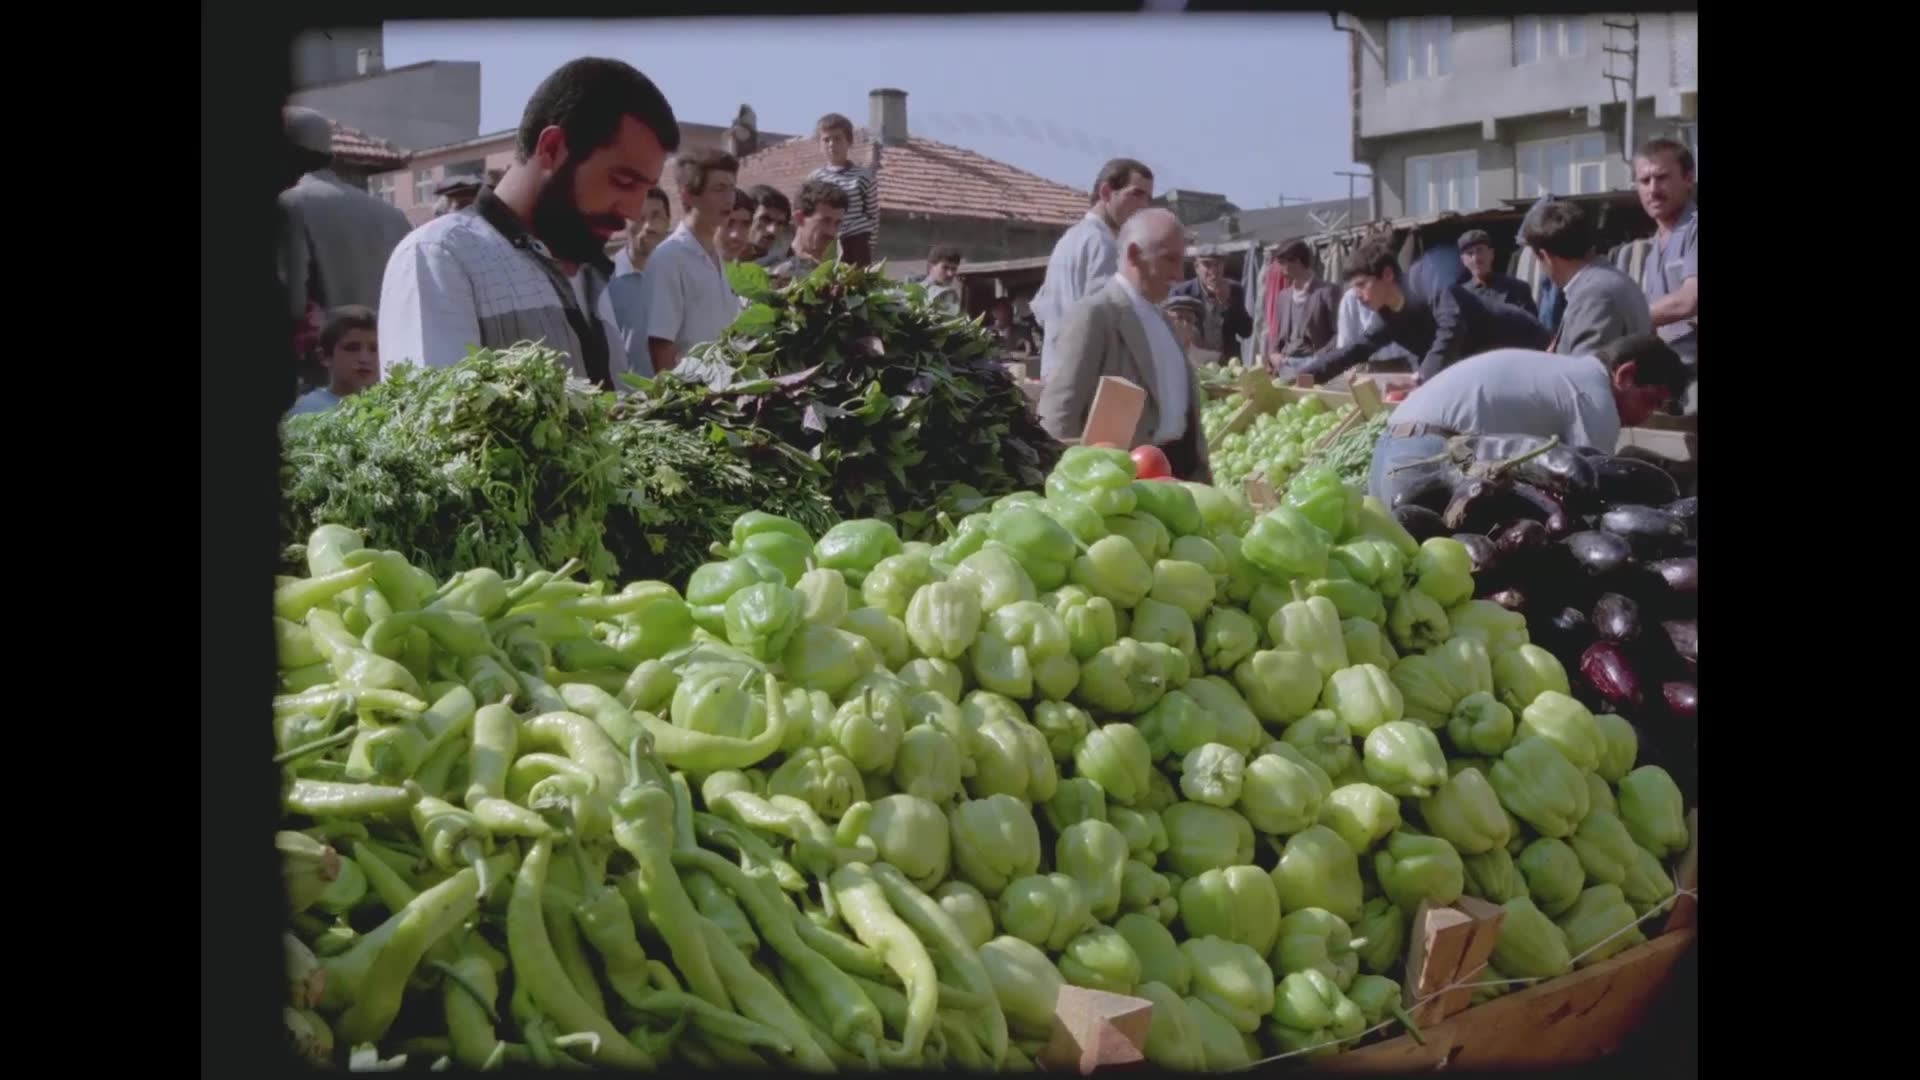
280, 58, 1699, 491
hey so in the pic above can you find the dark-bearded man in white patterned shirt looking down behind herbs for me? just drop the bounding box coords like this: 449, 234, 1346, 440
380, 58, 680, 390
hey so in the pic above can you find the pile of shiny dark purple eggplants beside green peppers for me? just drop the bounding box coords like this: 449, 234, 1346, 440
1388, 436, 1699, 796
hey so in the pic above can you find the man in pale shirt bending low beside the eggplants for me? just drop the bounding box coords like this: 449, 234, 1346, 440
1367, 334, 1688, 505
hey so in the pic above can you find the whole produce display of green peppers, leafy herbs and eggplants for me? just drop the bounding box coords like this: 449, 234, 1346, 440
273, 269, 1697, 1072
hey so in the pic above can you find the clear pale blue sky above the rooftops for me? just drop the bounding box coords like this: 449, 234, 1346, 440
386, 13, 1354, 209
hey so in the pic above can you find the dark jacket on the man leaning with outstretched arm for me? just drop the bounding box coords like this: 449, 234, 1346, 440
1298, 284, 1548, 382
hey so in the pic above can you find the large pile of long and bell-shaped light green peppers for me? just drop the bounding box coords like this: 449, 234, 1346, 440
275, 440, 1692, 1072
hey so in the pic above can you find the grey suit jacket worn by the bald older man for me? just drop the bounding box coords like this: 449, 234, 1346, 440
1039, 281, 1212, 482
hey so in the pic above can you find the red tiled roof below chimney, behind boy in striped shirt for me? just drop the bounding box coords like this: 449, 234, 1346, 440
739, 129, 1087, 225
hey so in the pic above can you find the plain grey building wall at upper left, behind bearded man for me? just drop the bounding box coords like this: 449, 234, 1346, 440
288, 60, 480, 150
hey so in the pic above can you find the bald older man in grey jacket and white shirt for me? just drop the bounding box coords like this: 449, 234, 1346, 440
1039, 209, 1212, 482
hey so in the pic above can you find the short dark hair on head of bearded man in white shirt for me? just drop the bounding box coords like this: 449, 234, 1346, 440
515, 56, 680, 161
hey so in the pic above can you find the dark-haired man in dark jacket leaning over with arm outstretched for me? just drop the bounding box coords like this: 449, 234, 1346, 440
1292, 236, 1548, 382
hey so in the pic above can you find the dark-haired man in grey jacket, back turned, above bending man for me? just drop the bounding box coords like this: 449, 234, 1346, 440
1521, 202, 1653, 356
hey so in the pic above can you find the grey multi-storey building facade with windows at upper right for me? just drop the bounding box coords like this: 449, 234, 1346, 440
1336, 12, 1699, 219
